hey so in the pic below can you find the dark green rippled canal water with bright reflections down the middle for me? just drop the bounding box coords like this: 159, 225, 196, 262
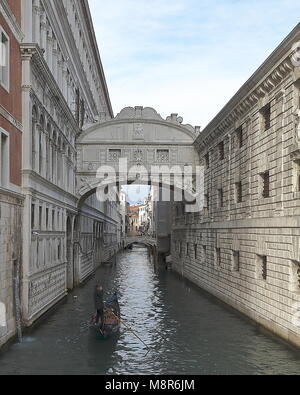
0, 246, 300, 375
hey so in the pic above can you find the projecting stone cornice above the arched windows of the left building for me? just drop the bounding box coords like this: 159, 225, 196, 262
21, 43, 79, 134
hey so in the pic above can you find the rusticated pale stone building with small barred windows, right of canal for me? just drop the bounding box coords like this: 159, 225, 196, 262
172, 25, 300, 346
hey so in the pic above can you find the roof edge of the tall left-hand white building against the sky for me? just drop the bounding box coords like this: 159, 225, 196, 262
82, 0, 114, 118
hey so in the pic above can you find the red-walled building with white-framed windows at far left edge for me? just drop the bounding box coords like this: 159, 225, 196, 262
0, 0, 23, 346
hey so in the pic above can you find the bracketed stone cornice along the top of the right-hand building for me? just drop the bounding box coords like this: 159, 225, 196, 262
195, 24, 300, 149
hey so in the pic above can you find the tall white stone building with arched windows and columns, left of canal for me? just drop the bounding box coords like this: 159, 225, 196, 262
21, 0, 118, 325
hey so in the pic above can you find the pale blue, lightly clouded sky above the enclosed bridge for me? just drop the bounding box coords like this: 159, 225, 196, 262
89, 0, 300, 127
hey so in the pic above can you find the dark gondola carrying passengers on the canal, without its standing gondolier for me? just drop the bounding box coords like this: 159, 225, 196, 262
91, 297, 120, 339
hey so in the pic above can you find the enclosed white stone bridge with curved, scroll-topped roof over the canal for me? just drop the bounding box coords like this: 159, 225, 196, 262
76, 107, 200, 200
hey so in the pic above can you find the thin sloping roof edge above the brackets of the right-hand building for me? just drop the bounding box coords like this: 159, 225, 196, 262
198, 23, 300, 139
